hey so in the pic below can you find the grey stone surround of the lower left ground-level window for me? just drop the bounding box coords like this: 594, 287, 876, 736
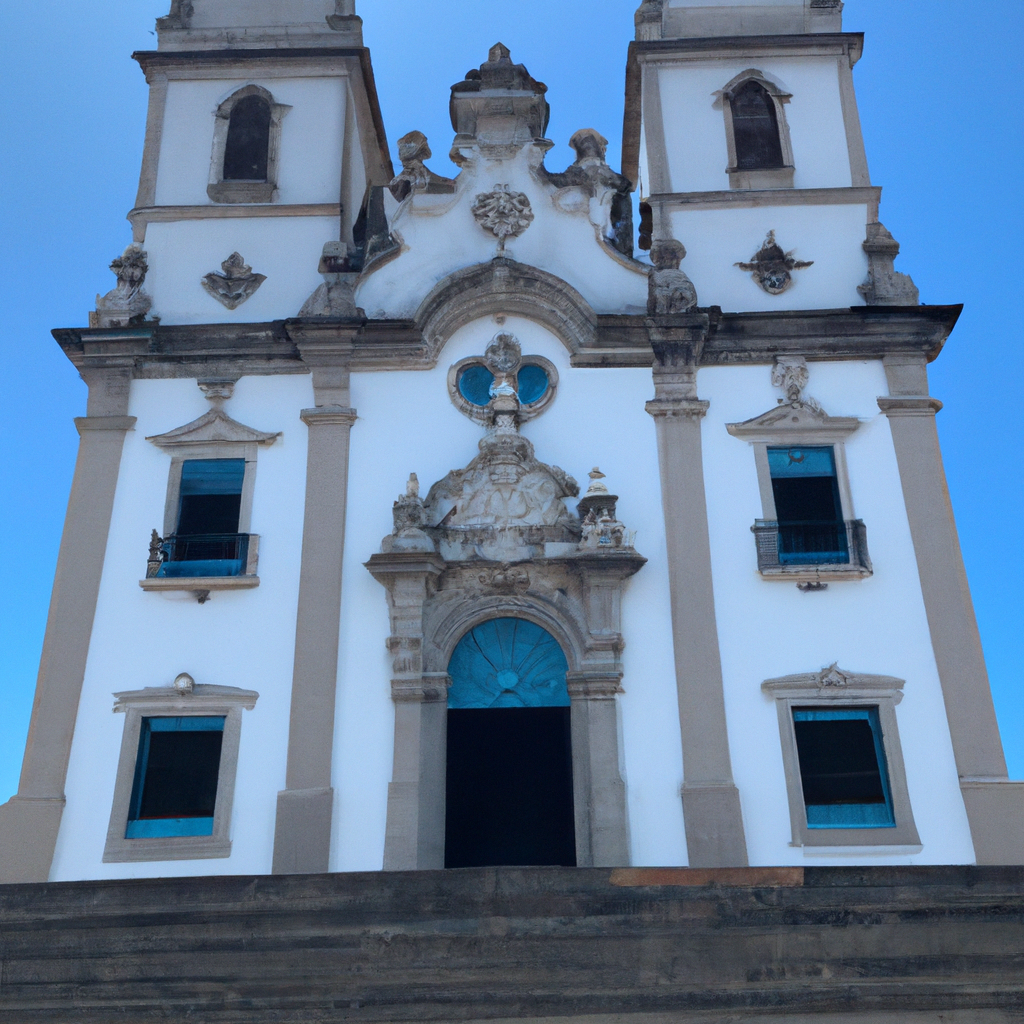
103, 686, 259, 864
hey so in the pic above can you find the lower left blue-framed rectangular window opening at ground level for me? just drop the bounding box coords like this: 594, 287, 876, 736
125, 717, 224, 839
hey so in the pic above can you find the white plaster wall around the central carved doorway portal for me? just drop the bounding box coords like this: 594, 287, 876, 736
331, 317, 686, 870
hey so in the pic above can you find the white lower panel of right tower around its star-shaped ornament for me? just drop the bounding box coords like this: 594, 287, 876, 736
671, 204, 867, 312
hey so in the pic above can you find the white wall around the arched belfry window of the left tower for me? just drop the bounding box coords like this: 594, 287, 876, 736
157, 75, 348, 206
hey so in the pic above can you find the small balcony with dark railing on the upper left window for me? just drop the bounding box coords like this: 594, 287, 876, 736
139, 530, 259, 604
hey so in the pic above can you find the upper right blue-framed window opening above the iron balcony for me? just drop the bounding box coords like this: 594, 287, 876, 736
768, 445, 850, 565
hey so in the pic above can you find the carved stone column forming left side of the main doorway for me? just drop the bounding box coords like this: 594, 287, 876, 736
367, 551, 452, 871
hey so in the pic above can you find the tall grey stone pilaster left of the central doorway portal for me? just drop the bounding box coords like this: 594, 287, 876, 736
273, 327, 357, 874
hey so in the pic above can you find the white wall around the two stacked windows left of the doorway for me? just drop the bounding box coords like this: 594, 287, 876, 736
50, 376, 313, 881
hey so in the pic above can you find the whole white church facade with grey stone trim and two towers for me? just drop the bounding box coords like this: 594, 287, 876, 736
0, 0, 1024, 882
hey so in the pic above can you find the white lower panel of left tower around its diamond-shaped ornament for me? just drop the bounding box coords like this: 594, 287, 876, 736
145, 217, 338, 324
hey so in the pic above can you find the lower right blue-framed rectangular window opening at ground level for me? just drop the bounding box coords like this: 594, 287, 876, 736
793, 708, 896, 828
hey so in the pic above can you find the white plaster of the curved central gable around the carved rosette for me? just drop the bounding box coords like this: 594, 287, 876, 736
356, 146, 647, 317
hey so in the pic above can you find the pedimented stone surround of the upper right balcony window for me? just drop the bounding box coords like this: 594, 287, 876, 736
726, 407, 871, 583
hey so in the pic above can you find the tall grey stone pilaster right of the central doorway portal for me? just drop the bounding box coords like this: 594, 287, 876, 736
647, 313, 748, 867
